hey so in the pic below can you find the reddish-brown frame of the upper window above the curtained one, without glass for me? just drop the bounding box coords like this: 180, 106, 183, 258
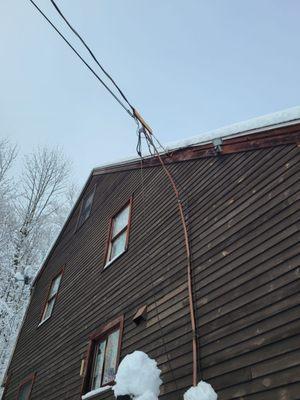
104, 196, 133, 268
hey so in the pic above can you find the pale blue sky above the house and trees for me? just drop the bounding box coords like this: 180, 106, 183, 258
0, 0, 300, 186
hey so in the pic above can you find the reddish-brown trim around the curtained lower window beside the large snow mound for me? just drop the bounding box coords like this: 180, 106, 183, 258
81, 315, 124, 395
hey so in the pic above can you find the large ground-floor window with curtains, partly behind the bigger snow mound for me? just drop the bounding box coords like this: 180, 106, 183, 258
84, 317, 123, 392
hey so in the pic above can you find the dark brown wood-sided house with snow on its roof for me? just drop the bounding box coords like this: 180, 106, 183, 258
3, 107, 300, 400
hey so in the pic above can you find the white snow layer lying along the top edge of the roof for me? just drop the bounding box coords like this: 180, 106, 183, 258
94, 106, 300, 170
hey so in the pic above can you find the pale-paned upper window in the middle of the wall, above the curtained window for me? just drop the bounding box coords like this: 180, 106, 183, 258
105, 200, 131, 265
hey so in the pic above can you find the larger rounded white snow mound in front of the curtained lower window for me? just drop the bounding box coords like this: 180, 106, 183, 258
113, 351, 162, 400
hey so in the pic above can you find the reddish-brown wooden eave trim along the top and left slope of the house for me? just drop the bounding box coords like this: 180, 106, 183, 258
32, 118, 300, 286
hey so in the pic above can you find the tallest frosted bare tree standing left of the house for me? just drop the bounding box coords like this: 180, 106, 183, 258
13, 148, 70, 272
